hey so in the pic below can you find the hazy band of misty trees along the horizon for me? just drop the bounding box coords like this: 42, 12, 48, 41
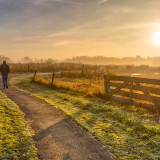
0, 55, 160, 66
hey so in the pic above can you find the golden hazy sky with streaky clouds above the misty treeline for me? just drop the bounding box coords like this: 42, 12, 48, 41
0, 0, 160, 60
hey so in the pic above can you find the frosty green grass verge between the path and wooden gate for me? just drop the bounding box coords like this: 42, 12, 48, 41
11, 77, 160, 160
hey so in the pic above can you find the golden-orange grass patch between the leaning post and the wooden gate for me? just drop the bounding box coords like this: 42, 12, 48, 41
34, 74, 104, 97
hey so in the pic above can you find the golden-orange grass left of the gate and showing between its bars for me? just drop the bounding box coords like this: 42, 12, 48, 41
33, 72, 160, 108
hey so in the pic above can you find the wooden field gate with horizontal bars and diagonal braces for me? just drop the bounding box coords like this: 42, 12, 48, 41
104, 75, 160, 109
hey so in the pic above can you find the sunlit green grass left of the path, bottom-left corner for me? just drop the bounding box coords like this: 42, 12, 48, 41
0, 92, 37, 160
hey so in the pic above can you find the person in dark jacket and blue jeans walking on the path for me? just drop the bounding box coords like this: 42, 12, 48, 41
0, 61, 10, 89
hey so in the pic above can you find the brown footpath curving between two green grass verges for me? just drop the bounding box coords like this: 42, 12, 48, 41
3, 87, 113, 160
